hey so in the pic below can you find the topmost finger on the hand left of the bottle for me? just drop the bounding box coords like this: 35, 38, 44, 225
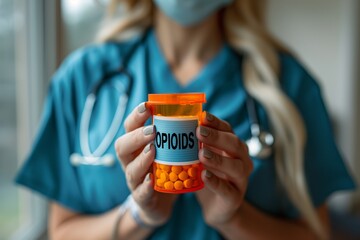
124, 102, 151, 132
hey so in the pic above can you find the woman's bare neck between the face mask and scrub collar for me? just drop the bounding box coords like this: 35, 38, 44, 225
154, 10, 223, 68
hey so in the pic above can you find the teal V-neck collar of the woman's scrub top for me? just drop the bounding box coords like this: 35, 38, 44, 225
149, 29, 231, 92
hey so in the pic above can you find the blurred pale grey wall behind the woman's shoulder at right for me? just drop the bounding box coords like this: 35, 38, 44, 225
268, 0, 360, 210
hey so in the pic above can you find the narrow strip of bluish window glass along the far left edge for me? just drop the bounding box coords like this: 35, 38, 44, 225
0, 0, 20, 239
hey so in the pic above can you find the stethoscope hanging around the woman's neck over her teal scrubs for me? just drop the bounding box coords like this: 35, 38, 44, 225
70, 31, 274, 167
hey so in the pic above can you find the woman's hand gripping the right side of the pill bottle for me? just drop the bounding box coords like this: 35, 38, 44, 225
196, 112, 253, 228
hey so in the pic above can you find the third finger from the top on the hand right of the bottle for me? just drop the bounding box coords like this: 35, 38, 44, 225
199, 148, 247, 188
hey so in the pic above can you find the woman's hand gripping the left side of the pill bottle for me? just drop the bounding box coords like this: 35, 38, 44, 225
115, 103, 176, 226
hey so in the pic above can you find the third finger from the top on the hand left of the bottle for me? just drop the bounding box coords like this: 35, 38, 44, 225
125, 143, 155, 190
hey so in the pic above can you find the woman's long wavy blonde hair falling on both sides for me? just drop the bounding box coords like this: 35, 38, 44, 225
98, 0, 327, 239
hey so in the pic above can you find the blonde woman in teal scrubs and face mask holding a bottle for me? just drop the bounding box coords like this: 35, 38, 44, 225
17, 0, 354, 239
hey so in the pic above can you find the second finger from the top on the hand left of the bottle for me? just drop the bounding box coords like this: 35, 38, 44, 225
115, 125, 155, 167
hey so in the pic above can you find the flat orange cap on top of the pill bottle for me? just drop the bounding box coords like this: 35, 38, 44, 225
148, 93, 206, 104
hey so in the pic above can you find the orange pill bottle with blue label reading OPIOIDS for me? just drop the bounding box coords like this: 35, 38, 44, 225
148, 93, 206, 194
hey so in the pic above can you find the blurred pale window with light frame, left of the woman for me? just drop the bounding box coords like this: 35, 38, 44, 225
0, 0, 56, 239
